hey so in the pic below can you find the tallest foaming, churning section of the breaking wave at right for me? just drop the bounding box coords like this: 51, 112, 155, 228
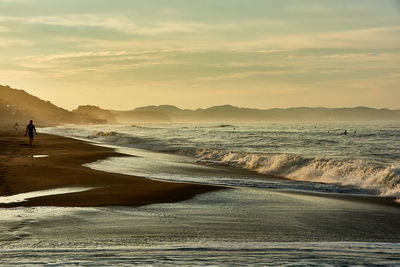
196, 149, 400, 198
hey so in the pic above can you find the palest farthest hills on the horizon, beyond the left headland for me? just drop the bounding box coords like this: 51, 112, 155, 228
122, 105, 400, 122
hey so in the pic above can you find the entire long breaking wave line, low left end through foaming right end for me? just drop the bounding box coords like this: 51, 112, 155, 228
86, 132, 400, 199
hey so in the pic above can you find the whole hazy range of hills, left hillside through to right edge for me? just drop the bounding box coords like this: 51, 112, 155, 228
0, 85, 400, 125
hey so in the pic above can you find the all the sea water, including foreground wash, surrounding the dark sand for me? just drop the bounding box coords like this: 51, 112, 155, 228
0, 122, 400, 266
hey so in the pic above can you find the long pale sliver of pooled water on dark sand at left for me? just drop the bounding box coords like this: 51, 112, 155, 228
0, 187, 94, 204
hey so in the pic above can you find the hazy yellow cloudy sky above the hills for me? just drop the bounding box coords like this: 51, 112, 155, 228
0, 0, 400, 110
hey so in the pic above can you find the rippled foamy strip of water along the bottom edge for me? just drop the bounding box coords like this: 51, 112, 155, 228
2, 243, 400, 266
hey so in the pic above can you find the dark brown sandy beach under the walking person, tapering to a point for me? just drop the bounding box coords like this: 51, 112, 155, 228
0, 129, 224, 208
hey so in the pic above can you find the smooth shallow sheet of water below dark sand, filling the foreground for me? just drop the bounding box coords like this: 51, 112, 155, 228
0, 188, 400, 266
